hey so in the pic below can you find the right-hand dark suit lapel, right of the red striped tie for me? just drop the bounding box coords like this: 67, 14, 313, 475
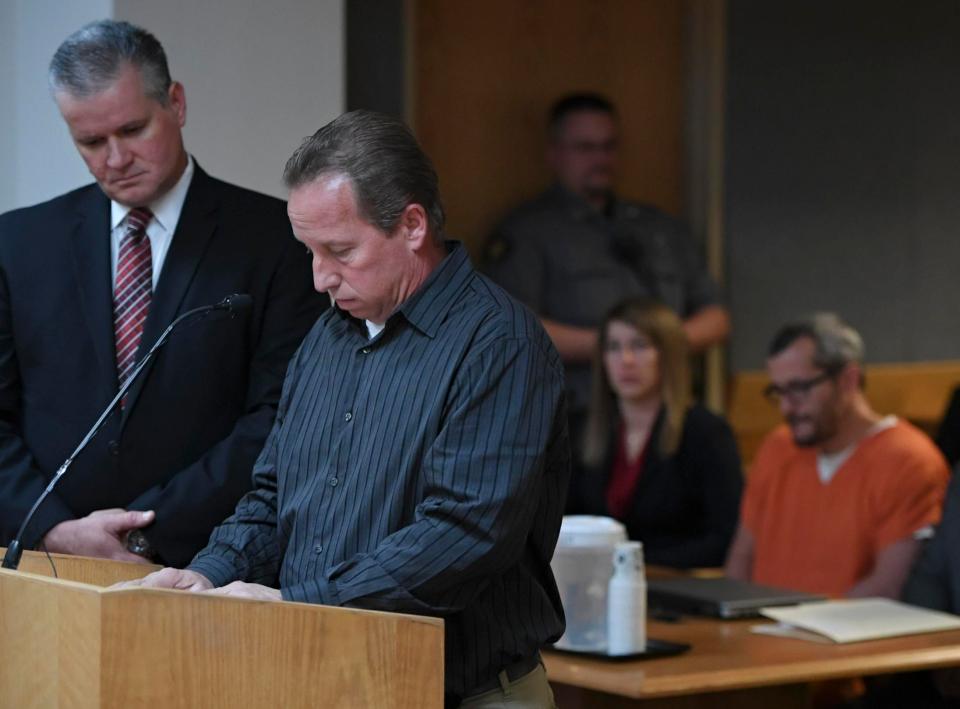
122, 163, 220, 423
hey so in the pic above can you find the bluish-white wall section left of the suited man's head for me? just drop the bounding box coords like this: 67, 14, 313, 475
0, 0, 113, 212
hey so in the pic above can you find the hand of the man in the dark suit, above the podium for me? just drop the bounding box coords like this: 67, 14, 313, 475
43, 508, 155, 564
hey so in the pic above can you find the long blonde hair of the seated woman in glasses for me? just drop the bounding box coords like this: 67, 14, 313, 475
583, 298, 691, 466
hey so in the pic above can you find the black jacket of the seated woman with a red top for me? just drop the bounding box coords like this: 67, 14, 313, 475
567, 406, 743, 568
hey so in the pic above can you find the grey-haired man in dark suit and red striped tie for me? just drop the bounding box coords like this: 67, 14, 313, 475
0, 21, 324, 564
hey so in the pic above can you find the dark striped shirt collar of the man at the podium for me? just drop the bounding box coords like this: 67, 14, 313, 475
334, 241, 473, 337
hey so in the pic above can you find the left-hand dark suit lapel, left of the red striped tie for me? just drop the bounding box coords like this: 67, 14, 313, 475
70, 186, 117, 390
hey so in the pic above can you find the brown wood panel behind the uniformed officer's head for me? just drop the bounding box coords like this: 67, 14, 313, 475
408, 0, 685, 253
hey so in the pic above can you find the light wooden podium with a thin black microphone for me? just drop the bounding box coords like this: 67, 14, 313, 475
0, 552, 443, 709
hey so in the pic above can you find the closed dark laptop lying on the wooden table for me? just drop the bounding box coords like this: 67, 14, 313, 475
647, 576, 826, 618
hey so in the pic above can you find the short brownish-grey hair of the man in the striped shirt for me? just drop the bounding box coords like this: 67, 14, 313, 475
283, 111, 444, 242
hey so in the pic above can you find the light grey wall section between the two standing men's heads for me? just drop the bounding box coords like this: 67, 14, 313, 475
116, 0, 345, 196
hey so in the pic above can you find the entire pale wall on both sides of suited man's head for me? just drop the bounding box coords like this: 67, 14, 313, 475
0, 0, 345, 212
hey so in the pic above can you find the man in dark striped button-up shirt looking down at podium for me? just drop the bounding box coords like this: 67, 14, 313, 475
134, 111, 570, 707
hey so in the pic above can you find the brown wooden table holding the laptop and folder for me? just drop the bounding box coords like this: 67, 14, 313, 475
544, 617, 960, 709
